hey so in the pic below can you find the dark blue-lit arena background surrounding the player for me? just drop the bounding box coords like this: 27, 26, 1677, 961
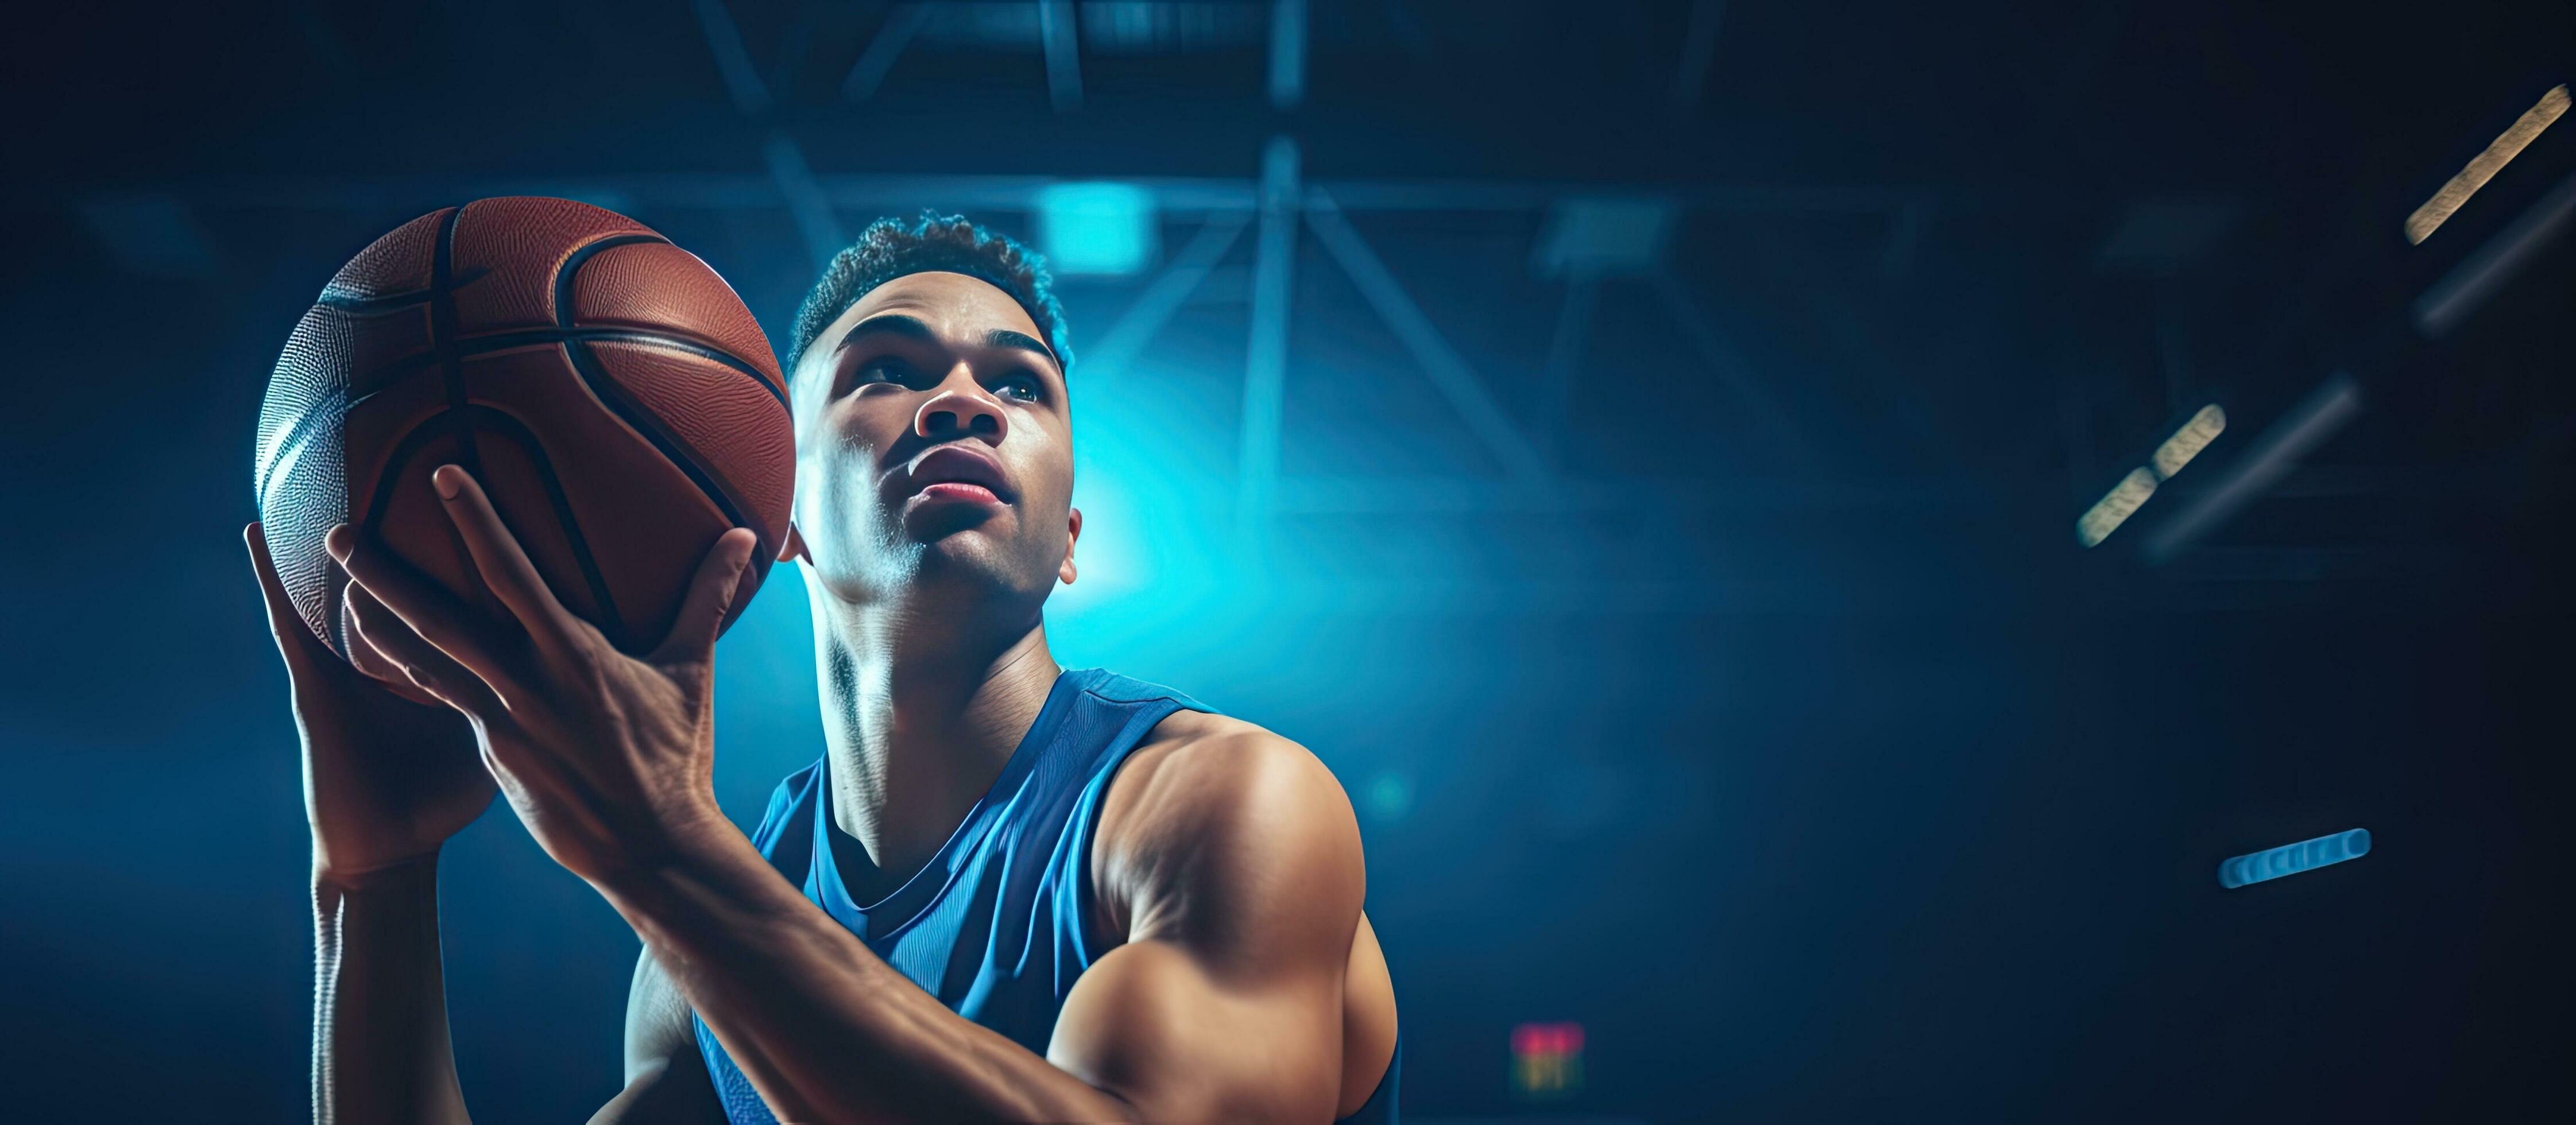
0, 0, 2576, 1123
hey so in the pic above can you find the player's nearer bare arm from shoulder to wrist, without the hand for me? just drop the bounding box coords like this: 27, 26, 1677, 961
603, 723, 1363, 1123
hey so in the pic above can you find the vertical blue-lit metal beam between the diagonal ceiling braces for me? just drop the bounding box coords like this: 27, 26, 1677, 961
1234, 137, 1301, 541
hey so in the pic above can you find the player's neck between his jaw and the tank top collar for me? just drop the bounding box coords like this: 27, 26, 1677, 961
814, 587, 1061, 901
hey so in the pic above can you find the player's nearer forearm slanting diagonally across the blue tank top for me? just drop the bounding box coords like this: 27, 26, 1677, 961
600, 834, 1131, 1123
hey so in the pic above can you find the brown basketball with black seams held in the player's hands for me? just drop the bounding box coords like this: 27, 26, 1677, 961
255, 198, 796, 700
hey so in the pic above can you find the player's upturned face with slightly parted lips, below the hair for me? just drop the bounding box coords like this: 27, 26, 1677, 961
791, 273, 1082, 603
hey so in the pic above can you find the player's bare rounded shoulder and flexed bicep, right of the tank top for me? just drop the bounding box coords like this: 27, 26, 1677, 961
1049, 728, 1366, 1123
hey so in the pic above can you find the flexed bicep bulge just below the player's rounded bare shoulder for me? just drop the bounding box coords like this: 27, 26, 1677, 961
1046, 942, 1342, 1123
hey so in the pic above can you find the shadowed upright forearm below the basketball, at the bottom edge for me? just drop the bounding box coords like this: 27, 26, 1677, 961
314, 852, 466, 1125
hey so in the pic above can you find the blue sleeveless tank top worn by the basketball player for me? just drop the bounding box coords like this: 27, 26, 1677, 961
690, 669, 1404, 1125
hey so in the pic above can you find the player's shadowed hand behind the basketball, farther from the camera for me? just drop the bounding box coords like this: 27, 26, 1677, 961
242, 522, 497, 886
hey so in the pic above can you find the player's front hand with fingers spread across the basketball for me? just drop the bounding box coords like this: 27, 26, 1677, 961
324, 466, 757, 883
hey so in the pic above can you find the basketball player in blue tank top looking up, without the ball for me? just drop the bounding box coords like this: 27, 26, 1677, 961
247, 216, 1396, 1125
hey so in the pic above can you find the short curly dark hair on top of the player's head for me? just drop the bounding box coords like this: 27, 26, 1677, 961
788, 211, 1074, 373
